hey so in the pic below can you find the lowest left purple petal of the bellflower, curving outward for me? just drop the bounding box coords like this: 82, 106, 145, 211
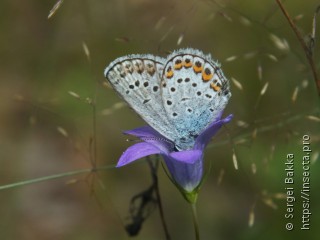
116, 142, 161, 167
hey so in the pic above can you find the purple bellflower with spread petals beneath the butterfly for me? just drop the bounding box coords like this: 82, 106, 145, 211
117, 114, 233, 203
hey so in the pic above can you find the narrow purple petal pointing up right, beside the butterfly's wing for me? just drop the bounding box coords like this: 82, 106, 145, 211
193, 114, 233, 150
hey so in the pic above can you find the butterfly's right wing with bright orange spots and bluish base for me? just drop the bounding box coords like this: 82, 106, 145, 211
161, 49, 231, 149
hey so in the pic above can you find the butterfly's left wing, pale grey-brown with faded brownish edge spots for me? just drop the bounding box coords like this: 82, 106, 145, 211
104, 55, 178, 138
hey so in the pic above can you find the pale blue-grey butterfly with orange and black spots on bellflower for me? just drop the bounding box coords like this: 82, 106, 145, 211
104, 48, 231, 151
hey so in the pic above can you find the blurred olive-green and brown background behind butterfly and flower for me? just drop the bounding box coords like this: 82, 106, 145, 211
0, 0, 320, 240
